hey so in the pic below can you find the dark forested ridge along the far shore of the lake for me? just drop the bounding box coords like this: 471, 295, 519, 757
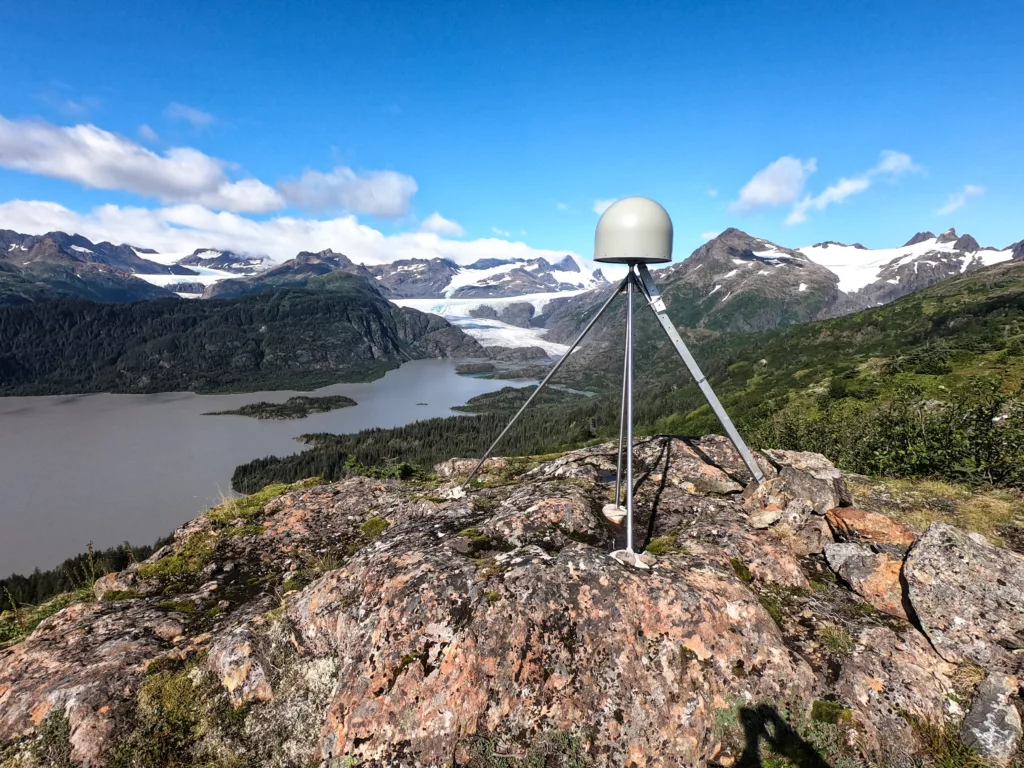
0, 272, 483, 394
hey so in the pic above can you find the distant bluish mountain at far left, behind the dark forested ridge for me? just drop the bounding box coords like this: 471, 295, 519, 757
0, 230, 178, 306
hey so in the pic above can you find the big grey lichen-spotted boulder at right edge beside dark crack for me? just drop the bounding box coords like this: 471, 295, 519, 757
903, 522, 1024, 674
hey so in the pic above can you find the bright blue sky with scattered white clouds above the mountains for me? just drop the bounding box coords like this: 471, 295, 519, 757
0, 0, 1024, 263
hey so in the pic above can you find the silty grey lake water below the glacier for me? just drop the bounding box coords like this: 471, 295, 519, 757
0, 359, 536, 578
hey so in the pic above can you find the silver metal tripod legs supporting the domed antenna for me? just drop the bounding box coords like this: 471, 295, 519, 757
463, 259, 764, 553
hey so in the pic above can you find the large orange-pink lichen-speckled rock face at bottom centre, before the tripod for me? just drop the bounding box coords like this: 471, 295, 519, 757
290, 530, 814, 766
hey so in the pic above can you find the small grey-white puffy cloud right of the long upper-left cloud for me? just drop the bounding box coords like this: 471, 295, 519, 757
278, 166, 419, 218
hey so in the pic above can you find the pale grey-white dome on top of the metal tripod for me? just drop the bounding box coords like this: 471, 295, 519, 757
594, 198, 672, 264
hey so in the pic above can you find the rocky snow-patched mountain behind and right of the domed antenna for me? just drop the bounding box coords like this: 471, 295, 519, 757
532, 228, 1024, 342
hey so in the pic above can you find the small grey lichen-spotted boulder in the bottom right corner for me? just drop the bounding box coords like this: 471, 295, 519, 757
961, 674, 1024, 765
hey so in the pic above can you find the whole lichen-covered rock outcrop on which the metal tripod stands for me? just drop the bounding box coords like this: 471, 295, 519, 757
0, 437, 1022, 768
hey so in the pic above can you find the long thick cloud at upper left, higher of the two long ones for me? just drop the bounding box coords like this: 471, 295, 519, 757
0, 112, 284, 213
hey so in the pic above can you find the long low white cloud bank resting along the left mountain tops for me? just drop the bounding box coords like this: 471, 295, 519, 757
0, 200, 577, 264
